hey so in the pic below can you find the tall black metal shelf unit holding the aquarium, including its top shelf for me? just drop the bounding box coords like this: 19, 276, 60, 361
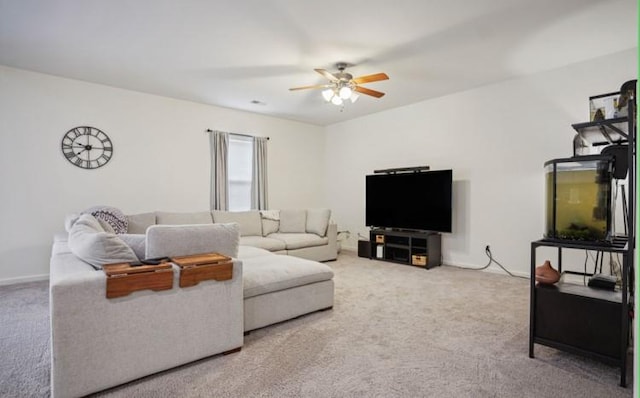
529, 98, 637, 387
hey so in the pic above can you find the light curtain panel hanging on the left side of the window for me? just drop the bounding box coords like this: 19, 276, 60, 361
209, 131, 229, 210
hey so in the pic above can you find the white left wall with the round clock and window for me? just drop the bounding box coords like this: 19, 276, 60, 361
0, 66, 327, 283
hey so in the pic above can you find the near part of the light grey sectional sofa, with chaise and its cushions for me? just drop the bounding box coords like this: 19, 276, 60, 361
50, 213, 334, 397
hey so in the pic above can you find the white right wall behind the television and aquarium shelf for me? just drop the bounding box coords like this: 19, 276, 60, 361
326, 49, 637, 275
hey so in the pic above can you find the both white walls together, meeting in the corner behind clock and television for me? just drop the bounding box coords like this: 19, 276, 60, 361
0, 49, 637, 283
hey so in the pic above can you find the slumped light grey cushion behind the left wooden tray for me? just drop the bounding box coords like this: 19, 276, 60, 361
68, 213, 138, 269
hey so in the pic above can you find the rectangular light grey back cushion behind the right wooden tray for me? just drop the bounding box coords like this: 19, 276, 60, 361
146, 223, 240, 258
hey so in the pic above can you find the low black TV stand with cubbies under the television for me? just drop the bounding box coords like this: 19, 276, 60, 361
369, 228, 442, 269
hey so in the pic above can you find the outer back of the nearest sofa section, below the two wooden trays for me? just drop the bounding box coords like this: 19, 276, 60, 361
50, 225, 244, 397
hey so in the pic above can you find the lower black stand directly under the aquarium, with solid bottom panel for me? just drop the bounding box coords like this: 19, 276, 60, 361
529, 239, 633, 387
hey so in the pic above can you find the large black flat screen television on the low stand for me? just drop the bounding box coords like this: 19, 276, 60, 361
365, 170, 453, 232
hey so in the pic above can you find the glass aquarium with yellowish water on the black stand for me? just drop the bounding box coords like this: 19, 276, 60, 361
544, 155, 613, 244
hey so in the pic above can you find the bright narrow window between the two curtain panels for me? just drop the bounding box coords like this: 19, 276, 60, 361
228, 134, 253, 211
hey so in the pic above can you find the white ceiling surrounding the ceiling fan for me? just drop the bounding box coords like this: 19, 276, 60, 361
0, 0, 637, 125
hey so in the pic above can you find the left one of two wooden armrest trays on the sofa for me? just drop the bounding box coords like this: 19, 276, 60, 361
102, 260, 173, 298
